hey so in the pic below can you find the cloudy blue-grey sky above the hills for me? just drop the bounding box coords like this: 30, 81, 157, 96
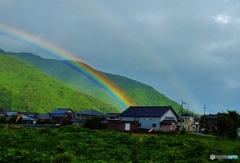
0, 0, 240, 114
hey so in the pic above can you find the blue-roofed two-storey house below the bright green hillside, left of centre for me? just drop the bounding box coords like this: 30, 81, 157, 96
49, 108, 75, 124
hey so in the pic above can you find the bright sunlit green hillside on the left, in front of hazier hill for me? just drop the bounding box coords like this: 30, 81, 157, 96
0, 53, 118, 113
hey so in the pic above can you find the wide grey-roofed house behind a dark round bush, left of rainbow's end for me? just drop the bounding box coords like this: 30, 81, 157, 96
71, 109, 107, 126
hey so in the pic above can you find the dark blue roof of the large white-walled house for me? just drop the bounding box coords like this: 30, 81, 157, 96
120, 106, 178, 117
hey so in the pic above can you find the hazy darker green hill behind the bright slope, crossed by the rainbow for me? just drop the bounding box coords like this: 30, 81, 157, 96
0, 50, 180, 113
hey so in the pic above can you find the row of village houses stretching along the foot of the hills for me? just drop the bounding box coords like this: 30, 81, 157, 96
0, 106, 220, 132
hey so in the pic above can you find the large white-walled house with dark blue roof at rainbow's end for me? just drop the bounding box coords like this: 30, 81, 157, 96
108, 106, 178, 131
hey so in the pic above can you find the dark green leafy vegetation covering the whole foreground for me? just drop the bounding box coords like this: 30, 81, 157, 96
0, 126, 240, 163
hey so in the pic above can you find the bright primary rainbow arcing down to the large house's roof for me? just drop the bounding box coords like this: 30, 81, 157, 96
0, 25, 135, 109
